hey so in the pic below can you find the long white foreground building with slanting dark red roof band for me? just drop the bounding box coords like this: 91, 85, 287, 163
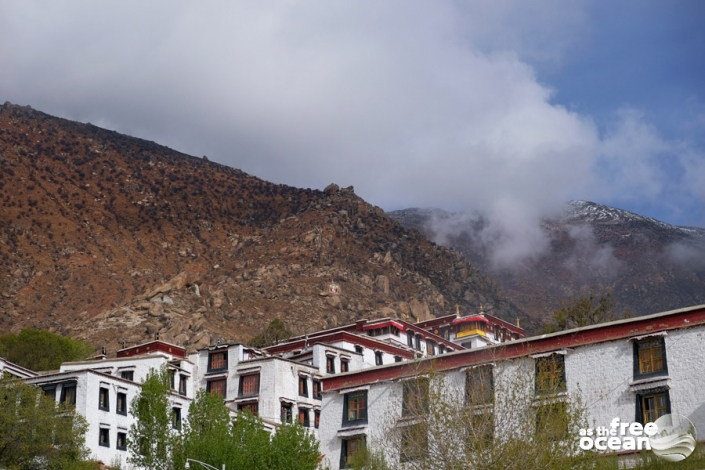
319, 306, 705, 468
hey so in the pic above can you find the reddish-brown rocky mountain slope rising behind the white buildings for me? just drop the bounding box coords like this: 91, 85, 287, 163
0, 103, 523, 351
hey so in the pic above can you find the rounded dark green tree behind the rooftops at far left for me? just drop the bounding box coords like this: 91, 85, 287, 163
0, 329, 94, 371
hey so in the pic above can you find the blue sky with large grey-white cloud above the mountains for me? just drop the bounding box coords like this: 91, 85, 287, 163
0, 0, 705, 239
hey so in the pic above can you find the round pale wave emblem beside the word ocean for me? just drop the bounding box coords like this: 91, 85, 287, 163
649, 414, 697, 462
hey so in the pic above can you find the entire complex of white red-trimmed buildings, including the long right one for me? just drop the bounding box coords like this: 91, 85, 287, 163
9, 306, 705, 468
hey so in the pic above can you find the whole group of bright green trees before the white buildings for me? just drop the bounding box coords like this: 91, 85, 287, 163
128, 369, 319, 470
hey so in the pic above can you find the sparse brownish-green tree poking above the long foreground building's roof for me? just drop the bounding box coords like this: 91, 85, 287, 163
544, 292, 632, 333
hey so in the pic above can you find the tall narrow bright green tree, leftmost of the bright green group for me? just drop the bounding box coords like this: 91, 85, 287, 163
127, 367, 179, 470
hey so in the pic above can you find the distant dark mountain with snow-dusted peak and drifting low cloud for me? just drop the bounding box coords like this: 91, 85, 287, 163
389, 201, 705, 321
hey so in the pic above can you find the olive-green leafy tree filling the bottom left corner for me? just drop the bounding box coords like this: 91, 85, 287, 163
0, 377, 88, 470
